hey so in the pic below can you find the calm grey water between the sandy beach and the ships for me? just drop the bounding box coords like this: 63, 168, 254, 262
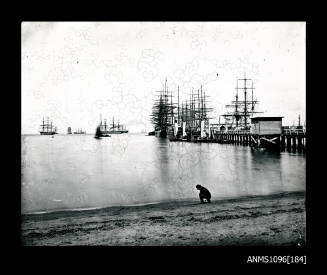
21, 134, 306, 213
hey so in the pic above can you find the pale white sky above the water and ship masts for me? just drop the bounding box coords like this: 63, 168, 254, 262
21, 22, 306, 134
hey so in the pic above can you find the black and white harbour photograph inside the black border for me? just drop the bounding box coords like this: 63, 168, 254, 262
21, 21, 310, 250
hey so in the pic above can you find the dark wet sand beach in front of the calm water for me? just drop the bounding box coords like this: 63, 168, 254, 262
22, 192, 306, 246
